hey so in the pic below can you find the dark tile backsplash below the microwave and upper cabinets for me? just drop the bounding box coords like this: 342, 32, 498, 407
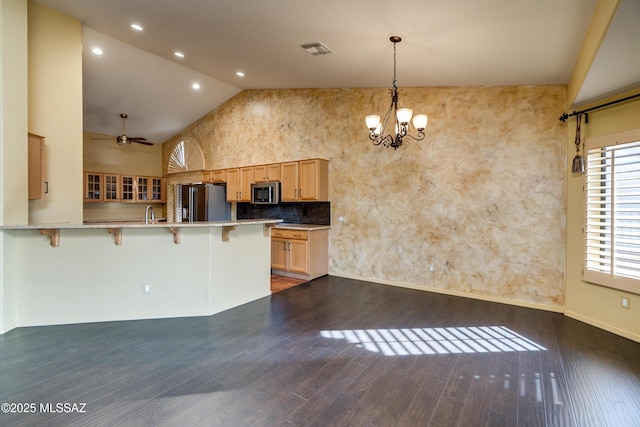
237, 202, 331, 225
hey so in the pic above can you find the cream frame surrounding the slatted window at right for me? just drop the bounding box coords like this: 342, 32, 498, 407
582, 128, 640, 294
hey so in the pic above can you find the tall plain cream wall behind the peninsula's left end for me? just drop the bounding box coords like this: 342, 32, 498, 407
29, 1, 82, 224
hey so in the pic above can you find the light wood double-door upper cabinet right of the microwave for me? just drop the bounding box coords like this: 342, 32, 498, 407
280, 159, 329, 202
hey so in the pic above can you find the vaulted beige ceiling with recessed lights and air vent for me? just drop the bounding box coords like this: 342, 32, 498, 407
36, 0, 640, 142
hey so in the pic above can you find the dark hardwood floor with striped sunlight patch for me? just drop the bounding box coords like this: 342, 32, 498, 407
0, 276, 640, 427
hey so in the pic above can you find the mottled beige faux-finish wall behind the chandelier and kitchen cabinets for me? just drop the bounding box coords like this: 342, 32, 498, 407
163, 86, 567, 308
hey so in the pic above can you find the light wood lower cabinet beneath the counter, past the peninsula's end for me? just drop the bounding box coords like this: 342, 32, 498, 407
271, 227, 329, 280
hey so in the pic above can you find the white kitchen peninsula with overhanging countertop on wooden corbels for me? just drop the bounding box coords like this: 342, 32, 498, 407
2, 219, 281, 326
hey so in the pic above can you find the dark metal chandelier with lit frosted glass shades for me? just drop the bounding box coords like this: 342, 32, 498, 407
365, 36, 428, 150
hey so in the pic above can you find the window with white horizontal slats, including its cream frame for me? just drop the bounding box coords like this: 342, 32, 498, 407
584, 130, 640, 292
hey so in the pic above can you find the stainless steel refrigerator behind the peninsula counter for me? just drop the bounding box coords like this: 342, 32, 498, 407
179, 184, 231, 222
